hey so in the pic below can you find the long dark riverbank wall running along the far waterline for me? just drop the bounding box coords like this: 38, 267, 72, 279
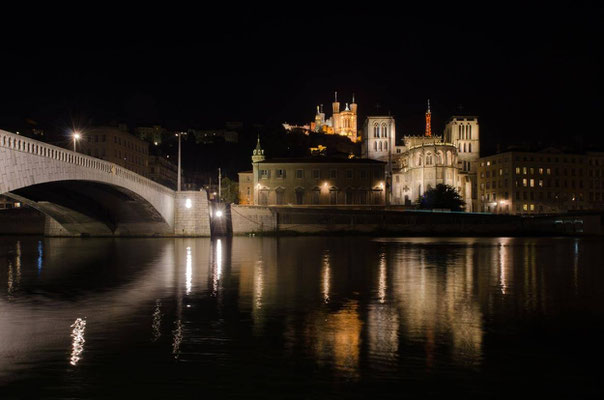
231, 205, 603, 236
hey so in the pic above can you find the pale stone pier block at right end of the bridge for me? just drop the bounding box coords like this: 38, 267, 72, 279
174, 190, 210, 236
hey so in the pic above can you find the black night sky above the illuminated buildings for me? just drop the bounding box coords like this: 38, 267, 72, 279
0, 7, 604, 155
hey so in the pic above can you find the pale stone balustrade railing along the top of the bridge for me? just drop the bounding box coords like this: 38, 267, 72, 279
0, 129, 174, 194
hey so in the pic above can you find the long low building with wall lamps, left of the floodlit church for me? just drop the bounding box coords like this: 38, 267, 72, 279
239, 138, 386, 206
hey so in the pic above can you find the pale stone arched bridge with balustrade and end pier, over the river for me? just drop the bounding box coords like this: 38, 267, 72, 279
0, 130, 210, 236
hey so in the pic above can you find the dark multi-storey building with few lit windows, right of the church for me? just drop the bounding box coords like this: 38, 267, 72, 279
477, 148, 604, 214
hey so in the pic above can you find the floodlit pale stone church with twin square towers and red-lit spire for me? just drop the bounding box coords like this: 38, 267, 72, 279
362, 101, 480, 211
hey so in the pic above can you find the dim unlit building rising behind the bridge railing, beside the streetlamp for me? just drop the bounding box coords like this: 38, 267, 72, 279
78, 127, 149, 176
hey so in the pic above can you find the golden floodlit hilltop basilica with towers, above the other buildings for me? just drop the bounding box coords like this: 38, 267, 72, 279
283, 92, 360, 142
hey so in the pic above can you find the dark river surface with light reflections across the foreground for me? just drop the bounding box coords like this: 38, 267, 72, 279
0, 237, 604, 399
